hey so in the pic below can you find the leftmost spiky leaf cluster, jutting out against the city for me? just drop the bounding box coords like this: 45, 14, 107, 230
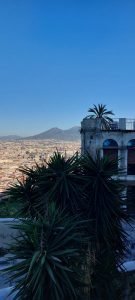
4, 164, 46, 218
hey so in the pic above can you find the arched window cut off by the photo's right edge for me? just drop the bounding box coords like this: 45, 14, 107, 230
127, 139, 135, 175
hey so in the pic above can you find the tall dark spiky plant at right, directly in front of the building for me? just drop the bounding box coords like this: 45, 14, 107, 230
81, 153, 128, 300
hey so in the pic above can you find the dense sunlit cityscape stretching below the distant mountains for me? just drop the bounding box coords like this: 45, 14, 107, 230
0, 140, 80, 193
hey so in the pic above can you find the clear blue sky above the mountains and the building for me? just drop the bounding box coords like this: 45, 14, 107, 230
0, 0, 135, 136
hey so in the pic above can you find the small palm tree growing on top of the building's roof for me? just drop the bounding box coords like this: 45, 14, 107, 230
88, 104, 114, 129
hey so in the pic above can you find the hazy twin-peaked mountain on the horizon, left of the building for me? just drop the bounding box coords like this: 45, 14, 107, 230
25, 126, 80, 141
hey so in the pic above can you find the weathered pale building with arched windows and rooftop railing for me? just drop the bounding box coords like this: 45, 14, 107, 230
81, 117, 135, 215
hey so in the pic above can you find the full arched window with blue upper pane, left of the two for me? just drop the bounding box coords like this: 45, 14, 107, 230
103, 139, 118, 161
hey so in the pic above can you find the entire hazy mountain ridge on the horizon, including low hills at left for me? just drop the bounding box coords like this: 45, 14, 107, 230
0, 126, 80, 141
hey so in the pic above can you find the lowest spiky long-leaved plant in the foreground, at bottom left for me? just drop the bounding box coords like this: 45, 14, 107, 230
3, 204, 87, 300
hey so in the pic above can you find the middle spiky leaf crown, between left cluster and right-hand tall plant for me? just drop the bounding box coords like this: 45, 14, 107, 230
36, 152, 83, 214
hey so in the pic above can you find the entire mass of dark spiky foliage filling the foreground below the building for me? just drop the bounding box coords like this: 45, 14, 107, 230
3, 152, 128, 300
